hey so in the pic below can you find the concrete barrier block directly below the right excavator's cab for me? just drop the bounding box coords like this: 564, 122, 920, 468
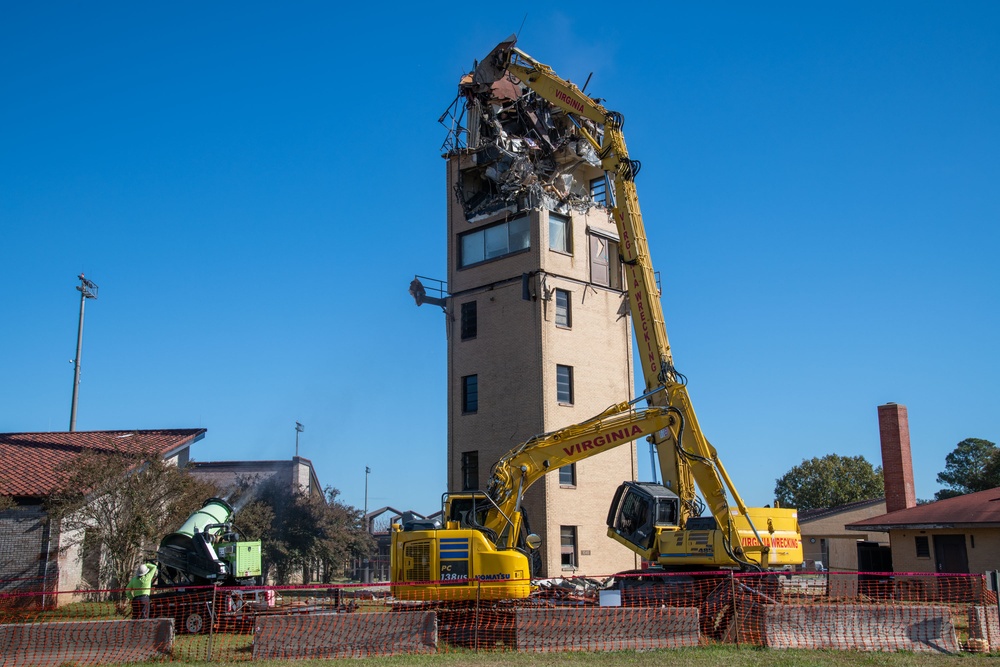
515, 607, 700, 651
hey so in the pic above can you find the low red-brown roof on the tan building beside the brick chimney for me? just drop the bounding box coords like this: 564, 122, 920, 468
845, 487, 1000, 531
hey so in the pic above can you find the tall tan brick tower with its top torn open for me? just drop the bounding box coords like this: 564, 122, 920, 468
445, 62, 637, 577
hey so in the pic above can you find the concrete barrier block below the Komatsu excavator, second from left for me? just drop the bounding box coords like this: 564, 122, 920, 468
253, 612, 437, 660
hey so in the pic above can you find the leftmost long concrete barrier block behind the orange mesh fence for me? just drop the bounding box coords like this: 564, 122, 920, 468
0, 618, 174, 667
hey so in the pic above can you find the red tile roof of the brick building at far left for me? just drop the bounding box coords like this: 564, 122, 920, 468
0, 428, 206, 498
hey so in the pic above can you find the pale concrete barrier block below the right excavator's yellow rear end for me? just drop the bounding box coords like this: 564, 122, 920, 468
764, 604, 959, 653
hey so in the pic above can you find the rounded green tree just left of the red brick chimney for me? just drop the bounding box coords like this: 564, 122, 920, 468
774, 454, 885, 510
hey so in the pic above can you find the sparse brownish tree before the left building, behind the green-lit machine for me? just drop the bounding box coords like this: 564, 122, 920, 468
46, 449, 217, 604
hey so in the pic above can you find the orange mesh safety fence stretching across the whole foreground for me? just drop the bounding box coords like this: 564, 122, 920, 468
0, 571, 1000, 667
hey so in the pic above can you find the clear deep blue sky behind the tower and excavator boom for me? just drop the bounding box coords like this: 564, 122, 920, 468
0, 2, 1000, 511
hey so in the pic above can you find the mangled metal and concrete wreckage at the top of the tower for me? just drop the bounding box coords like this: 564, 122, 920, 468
440, 58, 606, 222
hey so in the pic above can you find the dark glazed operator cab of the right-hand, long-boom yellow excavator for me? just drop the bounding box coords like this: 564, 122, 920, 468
608, 482, 679, 549
